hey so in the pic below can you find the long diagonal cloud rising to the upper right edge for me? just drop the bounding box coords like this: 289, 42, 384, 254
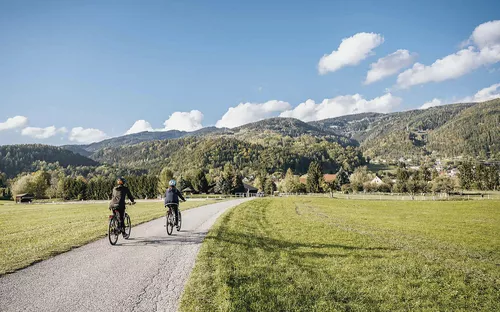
397, 20, 500, 88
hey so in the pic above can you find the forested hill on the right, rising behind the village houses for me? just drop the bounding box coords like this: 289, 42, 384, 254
311, 99, 500, 159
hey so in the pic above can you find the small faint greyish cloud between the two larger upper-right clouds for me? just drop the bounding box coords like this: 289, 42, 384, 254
365, 50, 416, 84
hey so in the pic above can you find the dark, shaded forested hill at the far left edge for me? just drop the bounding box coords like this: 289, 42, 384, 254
0, 144, 99, 177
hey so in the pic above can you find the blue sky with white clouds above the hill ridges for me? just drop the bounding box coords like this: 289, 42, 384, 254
0, 0, 500, 145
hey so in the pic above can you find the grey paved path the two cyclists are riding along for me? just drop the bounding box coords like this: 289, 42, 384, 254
0, 199, 250, 312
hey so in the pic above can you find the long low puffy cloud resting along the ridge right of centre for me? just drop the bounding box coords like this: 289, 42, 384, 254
280, 93, 402, 121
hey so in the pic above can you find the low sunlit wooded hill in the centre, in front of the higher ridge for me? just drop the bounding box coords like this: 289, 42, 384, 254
93, 136, 364, 173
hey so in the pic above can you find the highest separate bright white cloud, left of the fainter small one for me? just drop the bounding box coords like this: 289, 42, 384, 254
318, 32, 384, 74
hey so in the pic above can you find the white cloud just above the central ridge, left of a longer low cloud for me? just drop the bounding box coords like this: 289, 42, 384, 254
215, 100, 291, 128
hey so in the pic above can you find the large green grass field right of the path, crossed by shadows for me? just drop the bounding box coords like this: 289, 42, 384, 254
181, 198, 500, 311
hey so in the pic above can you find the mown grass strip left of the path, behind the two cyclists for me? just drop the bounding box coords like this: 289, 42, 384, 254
0, 200, 219, 275
